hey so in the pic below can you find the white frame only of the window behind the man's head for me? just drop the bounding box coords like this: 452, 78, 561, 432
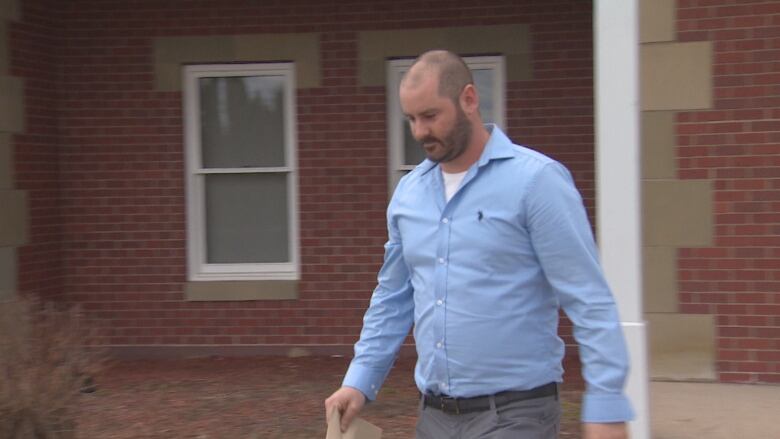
386, 56, 506, 191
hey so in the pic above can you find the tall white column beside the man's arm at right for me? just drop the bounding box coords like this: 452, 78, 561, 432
593, 0, 650, 439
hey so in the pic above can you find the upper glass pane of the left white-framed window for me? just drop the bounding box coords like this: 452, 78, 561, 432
199, 76, 285, 168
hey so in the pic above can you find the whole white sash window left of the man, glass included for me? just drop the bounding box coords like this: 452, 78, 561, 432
183, 63, 299, 281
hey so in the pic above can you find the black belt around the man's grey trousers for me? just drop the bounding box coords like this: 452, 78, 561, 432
423, 382, 558, 415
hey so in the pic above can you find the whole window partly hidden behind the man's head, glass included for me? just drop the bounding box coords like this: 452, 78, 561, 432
387, 56, 506, 193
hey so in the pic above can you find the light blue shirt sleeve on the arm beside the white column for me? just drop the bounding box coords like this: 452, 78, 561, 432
525, 162, 634, 422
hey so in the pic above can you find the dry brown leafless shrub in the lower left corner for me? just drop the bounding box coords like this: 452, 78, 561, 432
0, 298, 105, 439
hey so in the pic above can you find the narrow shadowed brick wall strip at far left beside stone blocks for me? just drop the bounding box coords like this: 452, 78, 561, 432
8, 0, 63, 298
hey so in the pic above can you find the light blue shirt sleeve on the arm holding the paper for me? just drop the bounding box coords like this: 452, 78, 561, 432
342, 196, 414, 400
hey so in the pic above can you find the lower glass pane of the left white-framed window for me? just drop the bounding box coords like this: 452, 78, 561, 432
205, 173, 290, 264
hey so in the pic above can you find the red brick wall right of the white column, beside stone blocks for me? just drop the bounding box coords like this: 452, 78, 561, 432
677, 0, 780, 383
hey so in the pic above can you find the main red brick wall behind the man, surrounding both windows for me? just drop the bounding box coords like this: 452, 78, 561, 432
14, 0, 593, 382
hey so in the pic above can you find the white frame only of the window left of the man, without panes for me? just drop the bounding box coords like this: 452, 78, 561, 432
182, 63, 300, 281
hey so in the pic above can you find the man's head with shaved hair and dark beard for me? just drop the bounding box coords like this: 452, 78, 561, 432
400, 50, 482, 168
